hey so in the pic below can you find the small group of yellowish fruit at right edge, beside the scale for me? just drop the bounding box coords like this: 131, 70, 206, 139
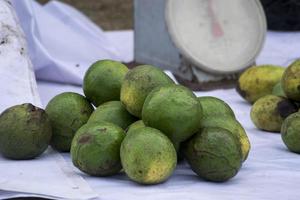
237, 60, 300, 153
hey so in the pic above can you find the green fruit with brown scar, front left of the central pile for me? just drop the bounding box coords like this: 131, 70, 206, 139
71, 122, 125, 176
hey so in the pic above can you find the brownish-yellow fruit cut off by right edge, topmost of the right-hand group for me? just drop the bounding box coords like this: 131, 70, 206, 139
281, 60, 300, 101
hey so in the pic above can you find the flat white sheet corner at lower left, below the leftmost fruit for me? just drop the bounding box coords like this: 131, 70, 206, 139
0, 148, 97, 199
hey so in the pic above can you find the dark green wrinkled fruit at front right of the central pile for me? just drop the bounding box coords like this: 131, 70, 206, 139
183, 128, 242, 182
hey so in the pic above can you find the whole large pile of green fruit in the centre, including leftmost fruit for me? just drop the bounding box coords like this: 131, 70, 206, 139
0, 60, 250, 184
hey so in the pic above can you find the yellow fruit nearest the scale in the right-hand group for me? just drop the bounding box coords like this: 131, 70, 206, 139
237, 65, 285, 103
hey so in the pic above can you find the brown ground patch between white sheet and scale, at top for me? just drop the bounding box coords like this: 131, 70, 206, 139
38, 0, 133, 30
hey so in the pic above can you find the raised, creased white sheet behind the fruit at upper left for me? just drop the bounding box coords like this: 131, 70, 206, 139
12, 0, 126, 84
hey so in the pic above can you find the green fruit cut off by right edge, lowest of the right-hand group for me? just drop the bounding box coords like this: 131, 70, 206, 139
281, 112, 300, 153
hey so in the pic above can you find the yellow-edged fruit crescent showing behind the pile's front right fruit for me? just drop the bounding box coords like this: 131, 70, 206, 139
201, 117, 251, 161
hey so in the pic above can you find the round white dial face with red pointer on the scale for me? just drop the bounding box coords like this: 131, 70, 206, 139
166, 0, 266, 74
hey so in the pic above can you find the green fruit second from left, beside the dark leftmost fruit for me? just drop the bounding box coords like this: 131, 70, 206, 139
46, 92, 94, 152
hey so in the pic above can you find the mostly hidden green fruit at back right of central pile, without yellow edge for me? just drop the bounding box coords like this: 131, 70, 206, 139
198, 96, 235, 119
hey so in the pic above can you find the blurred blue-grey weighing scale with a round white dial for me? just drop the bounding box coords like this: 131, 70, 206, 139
135, 0, 267, 90
